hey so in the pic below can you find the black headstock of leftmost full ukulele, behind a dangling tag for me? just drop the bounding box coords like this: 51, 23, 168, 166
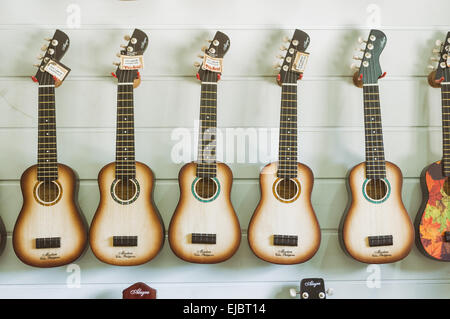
33, 30, 70, 87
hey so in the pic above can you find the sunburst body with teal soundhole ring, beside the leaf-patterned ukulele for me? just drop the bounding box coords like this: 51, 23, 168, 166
341, 161, 414, 264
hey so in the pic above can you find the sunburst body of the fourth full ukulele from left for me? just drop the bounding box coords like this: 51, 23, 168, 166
248, 163, 320, 264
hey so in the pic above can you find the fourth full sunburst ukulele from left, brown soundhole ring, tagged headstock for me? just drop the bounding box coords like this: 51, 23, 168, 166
248, 30, 320, 264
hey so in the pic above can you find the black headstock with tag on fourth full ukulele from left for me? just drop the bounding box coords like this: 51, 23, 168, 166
276, 29, 310, 85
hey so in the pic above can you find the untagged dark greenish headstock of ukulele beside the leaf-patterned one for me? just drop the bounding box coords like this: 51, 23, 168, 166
353, 30, 387, 87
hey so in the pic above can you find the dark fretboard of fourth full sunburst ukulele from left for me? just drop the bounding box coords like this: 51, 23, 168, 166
277, 82, 297, 178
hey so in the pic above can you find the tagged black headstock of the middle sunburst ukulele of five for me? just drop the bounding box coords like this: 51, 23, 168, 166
194, 31, 230, 82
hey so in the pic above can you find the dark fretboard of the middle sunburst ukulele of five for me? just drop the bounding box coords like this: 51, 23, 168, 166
197, 82, 217, 177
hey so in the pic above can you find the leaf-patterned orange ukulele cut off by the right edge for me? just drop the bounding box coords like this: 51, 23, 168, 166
415, 32, 450, 261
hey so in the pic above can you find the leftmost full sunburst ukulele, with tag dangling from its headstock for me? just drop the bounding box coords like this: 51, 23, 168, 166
13, 30, 87, 267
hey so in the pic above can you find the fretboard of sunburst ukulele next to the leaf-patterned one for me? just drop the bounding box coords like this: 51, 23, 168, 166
363, 84, 386, 179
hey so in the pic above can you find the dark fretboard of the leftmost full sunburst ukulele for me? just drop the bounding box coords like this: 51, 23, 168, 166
37, 80, 58, 181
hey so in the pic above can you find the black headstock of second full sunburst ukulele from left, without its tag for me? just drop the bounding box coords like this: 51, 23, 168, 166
115, 29, 149, 82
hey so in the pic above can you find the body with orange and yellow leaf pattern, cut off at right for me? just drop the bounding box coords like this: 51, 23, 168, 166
415, 161, 450, 261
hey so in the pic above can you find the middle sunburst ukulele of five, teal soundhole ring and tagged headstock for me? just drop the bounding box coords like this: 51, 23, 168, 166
169, 32, 241, 263
